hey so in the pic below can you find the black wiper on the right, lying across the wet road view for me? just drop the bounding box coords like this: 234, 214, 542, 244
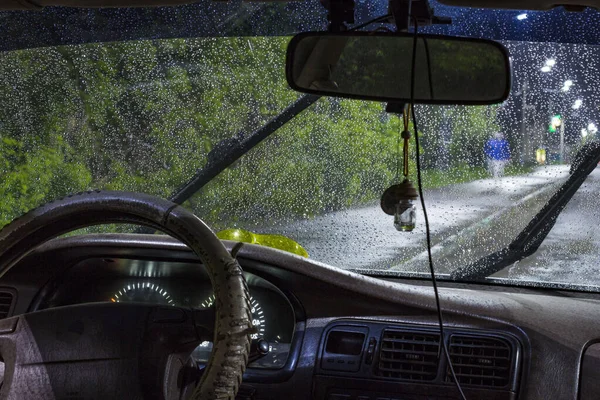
450, 142, 600, 281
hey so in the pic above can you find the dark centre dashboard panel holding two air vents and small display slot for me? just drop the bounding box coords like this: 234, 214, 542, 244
313, 320, 522, 400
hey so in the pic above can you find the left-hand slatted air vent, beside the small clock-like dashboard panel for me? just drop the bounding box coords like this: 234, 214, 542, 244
377, 330, 440, 381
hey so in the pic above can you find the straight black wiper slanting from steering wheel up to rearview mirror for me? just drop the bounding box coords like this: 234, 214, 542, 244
169, 94, 321, 204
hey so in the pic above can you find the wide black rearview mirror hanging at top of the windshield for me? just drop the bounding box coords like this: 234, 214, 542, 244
286, 32, 511, 105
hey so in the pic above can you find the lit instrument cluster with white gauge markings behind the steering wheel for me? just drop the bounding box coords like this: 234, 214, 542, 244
37, 257, 295, 369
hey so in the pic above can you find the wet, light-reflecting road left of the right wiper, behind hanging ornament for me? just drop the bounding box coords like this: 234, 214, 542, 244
276, 166, 568, 272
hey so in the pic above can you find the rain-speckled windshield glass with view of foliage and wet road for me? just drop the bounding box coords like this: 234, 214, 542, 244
0, 2, 600, 290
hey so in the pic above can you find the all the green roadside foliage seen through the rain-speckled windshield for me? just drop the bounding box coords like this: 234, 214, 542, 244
0, 37, 506, 229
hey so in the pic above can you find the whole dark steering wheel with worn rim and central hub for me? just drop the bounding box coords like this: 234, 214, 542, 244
0, 191, 253, 400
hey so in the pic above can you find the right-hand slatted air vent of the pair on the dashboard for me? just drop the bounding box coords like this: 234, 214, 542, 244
446, 335, 512, 387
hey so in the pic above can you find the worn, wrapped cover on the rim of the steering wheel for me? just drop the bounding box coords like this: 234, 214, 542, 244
0, 191, 253, 400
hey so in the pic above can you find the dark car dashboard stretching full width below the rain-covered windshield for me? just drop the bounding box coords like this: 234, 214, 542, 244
0, 235, 600, 400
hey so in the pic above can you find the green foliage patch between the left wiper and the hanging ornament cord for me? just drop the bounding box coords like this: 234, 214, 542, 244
192, 99, 399, 228
